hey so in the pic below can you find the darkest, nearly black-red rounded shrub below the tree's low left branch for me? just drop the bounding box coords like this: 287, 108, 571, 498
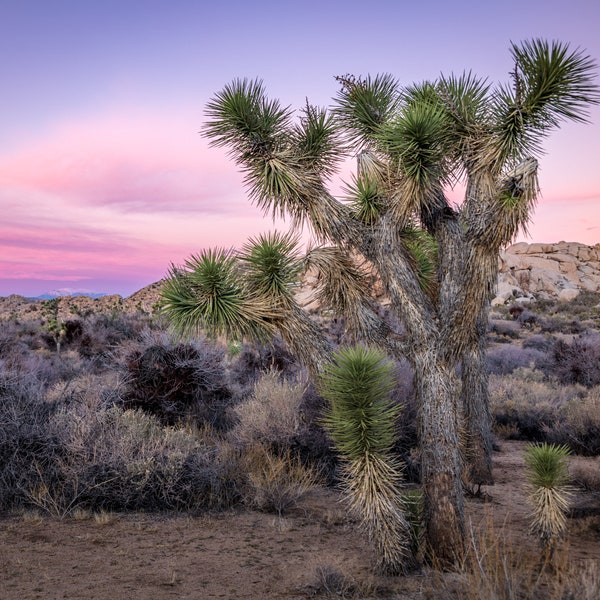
122, 334, 232, 429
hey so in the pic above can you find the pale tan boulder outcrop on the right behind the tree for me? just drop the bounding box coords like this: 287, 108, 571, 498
493, 242, 600, 305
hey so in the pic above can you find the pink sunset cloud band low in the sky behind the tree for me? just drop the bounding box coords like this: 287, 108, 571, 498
0, 104, 600, 295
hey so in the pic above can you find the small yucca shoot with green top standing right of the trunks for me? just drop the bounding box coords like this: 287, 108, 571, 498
525, 442, 571, 550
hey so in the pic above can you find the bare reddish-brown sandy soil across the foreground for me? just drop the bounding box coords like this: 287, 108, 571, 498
0, 441, 600, 600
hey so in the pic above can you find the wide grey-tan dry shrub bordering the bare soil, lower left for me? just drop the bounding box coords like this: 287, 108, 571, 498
39, 405, 239, 514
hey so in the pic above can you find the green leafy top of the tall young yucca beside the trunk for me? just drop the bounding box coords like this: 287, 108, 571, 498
321, 346, 399, 459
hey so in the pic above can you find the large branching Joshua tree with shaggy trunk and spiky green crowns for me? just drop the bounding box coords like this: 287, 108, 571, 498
163, 40, 600, 562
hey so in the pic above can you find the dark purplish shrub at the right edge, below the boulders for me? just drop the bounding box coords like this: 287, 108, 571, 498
551, 333, 600, 387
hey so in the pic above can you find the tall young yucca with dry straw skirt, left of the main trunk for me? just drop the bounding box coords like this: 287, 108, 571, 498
321, 346, 412, 573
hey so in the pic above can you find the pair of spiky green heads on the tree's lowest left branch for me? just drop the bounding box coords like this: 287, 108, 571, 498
161, 232, 300, 339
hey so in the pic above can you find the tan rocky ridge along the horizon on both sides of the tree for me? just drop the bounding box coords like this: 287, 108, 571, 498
0, 242, 600, 320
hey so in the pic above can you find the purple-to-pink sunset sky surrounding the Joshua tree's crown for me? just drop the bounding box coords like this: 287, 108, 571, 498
0, 0, 600, 296
